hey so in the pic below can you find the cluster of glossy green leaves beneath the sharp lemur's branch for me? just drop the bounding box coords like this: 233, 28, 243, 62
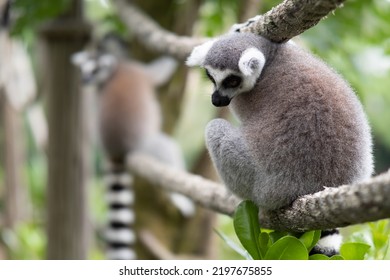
229, 201, 371, 260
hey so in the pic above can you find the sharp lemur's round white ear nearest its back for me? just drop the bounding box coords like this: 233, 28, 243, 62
238, 48, 265, 76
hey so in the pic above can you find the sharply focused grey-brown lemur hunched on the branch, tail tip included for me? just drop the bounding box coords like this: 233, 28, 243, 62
187, 33, 373, 255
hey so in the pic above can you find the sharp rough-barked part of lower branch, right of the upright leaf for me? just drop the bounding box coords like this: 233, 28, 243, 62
259, 173, 390, 231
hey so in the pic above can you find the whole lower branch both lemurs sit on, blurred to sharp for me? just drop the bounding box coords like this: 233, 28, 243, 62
128, 154, 390, 231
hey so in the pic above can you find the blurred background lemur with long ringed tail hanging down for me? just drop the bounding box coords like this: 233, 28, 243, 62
73, 47, 195, 259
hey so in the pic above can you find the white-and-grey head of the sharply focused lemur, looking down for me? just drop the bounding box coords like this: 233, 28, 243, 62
187, 34, 265, 107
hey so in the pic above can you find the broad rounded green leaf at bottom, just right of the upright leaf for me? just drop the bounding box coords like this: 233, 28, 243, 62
264, 236, 309, 260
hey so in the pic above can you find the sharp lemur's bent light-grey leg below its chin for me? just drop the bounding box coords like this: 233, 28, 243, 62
206, 119, 256, 198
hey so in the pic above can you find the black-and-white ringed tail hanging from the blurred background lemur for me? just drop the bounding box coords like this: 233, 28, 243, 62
105, 166, 136, 260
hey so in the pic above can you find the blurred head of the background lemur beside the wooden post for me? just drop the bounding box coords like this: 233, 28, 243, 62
72, 51, 117, 84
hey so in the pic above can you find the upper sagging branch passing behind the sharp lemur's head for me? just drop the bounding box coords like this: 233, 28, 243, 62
114, 0, 345, 57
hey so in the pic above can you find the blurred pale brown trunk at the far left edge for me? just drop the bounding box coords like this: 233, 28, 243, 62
0, 29, 28, 234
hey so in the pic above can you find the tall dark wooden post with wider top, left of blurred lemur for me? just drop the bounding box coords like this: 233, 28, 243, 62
41, 0, 90, 259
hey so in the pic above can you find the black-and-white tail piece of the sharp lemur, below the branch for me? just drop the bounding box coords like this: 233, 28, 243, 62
310, 229, 342, 257
